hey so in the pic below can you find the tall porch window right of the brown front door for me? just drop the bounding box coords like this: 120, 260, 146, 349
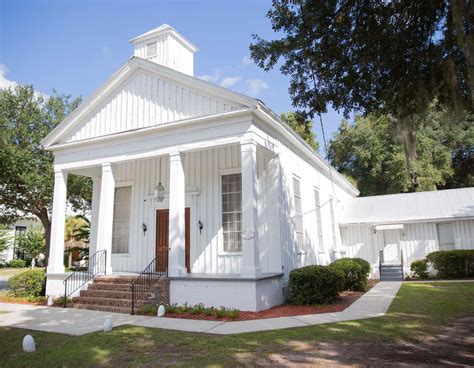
222, 174, 242, 252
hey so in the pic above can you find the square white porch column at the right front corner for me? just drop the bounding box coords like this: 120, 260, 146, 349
240, 140, 261, 278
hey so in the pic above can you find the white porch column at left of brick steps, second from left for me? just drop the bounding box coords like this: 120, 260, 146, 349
96, 163, 115, 274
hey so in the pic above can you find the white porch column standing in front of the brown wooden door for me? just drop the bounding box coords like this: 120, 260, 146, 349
168, 152, 186, 277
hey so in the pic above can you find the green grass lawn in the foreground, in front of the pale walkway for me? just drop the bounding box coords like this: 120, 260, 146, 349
0, 282, 474, 367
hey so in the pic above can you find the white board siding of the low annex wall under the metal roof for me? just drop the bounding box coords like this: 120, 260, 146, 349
341, 220, 474, 277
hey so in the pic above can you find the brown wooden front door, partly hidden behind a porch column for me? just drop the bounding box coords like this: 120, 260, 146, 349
156, 207, 191, 272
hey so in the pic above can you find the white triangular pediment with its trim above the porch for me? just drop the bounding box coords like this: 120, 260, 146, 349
43, 58, 257, 147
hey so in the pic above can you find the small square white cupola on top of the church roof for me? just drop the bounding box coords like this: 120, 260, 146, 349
130, 24, 198, 76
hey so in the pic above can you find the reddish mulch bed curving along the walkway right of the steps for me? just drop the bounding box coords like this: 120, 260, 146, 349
159, 280, 378, 321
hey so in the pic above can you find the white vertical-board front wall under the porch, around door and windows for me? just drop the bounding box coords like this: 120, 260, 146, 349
112, 146, 279, 274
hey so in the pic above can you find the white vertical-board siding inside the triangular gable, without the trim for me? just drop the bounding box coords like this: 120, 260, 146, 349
62, 69, 242, 143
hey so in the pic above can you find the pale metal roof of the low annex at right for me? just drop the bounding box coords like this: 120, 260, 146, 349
340, 187, 474, 224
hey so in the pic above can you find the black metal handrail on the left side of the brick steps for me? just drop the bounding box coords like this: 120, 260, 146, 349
63, 250, 107, 308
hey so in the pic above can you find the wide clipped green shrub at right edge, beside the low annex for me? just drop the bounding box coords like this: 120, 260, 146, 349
426, 249, 474, 279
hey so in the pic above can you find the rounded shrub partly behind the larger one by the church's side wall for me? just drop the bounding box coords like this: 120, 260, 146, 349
329, 258, 370, 291
